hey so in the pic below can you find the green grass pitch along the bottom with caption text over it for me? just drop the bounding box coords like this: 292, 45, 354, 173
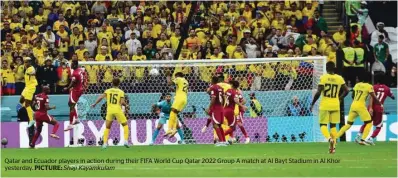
1, 142, 397, 177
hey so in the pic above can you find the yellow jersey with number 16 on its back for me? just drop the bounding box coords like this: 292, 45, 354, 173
104, 88, 124, 113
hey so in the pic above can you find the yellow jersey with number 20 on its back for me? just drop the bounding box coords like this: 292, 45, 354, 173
319, 74, 345, 111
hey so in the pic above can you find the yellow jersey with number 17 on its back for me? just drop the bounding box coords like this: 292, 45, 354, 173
351, 82, 374, 109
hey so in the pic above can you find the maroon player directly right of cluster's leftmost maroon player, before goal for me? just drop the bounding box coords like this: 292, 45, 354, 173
224, 80, 246, 140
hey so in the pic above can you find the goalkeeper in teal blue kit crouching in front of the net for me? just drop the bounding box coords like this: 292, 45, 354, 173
149, 93, 185, 145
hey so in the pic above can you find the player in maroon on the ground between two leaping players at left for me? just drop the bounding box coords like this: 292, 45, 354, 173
29, 86, 59, 148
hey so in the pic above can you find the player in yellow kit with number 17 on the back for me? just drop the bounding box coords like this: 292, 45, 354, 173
337, 73, 383, 145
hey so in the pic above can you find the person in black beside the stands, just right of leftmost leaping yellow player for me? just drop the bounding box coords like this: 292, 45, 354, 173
37, 59, 58, 93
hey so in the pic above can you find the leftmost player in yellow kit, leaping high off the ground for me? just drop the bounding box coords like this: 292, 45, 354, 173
19, 57, 37, 127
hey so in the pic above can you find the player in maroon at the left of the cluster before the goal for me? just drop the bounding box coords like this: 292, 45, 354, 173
202, 76, 227, 146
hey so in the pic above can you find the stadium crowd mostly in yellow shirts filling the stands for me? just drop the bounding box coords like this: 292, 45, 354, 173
1, 0, 396, 95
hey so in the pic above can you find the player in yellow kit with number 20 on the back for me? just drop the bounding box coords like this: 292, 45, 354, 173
311, 61, 349, 153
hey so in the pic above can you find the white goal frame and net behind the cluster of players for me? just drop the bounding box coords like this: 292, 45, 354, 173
78, 56, 326, 145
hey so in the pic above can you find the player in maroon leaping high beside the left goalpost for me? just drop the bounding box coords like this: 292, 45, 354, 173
64, 60, 87, 131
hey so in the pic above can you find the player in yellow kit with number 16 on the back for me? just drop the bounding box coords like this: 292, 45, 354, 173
91, 78, 129, 149
